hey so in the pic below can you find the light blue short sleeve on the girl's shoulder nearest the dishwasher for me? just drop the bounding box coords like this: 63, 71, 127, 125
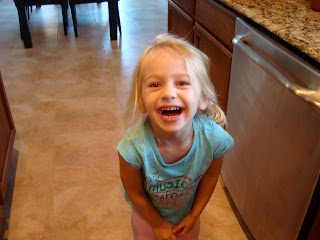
212, 124, 234, 159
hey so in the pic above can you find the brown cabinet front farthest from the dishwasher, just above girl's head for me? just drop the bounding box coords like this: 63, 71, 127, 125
168, 0, 194, 43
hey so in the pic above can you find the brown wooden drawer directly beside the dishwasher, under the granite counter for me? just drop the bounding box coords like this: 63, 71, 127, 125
195, 0, 237, 51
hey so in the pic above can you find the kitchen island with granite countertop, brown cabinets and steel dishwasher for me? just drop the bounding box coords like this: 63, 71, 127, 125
168, 0, 320, 240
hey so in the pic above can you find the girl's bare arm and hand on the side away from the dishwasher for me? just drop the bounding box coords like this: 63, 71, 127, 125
118, 154, 176, 240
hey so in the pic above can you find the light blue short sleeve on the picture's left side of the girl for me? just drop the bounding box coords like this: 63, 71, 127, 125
117, 137, 142, 169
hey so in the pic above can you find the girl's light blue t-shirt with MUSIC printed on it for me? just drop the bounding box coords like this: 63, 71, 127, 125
117, 117, 233, 225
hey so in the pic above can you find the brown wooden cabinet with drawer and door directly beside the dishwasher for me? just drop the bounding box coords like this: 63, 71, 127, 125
194, 0, 237, 112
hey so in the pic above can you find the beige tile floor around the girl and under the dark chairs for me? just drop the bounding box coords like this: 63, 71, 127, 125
0, 0, 247, 240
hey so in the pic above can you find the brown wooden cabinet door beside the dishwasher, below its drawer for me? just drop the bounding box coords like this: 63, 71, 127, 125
194, 23, 232, 112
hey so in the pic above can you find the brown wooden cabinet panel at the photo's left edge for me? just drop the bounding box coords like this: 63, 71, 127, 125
0, 73, 16, 205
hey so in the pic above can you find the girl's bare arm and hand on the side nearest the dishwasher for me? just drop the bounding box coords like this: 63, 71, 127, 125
173, 157, 223, 237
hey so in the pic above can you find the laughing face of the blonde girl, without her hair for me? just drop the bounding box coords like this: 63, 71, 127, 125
140, 51, 206, 137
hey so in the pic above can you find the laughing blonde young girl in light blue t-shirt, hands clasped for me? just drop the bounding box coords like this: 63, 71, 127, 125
117, 35, 233, 240
